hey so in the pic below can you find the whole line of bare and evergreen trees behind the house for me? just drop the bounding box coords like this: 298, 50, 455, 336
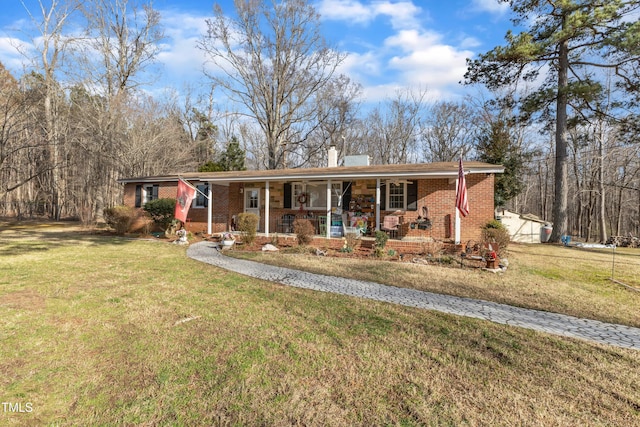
0, 0, 640, 244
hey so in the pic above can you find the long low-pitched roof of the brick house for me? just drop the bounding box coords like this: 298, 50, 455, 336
118, 161, 504, 185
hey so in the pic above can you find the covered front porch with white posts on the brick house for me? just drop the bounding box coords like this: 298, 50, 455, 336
199, 165, 476, 242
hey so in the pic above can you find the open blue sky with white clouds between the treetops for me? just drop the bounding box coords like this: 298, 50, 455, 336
0, 0, 511, 102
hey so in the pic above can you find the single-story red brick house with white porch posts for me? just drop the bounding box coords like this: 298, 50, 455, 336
119, 153, 504, 242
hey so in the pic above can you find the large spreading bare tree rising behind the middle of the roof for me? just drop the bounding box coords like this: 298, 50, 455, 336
198, 0, 345, 169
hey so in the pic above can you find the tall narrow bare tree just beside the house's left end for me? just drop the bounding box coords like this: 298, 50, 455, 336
78, 0, 164, 221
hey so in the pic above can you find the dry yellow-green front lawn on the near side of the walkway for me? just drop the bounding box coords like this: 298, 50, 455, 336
0, 226, 640, 426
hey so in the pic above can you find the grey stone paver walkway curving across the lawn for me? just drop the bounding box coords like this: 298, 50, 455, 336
187, 242, 640, 350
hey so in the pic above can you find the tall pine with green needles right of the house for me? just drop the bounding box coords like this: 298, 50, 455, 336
465, 0, 640, 242
